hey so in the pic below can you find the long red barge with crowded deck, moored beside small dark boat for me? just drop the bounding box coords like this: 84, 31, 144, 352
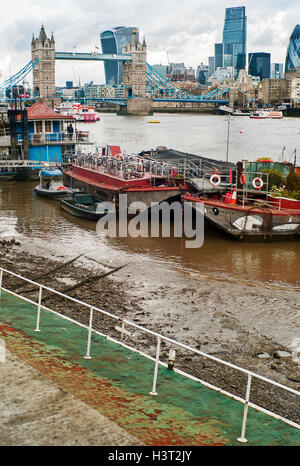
64, 148, 190, 212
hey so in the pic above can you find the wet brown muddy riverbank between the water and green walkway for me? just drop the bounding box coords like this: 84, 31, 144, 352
0, 238, 300, 423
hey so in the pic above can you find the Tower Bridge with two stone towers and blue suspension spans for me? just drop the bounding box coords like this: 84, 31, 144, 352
0, 25, 230, 114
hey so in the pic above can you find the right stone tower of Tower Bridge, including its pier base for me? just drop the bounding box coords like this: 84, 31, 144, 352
122, 30, 152, 115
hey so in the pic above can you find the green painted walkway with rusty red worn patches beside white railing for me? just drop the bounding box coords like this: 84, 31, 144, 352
0, 291, 300, 446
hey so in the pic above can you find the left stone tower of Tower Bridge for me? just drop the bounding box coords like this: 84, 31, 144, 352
31, 25, 55, 104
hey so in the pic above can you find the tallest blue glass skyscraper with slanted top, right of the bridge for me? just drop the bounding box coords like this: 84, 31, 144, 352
223, 6, 247, 78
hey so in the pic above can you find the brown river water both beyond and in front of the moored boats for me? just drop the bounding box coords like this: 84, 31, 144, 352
0, 114, 300, 287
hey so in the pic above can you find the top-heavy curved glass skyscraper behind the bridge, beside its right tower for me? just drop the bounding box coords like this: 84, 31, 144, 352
100, 26, 139, 85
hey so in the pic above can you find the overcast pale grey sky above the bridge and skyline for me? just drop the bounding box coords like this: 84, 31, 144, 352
0, 0, 300, 85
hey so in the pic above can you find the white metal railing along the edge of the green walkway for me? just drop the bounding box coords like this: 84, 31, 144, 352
0, 267, 300, 443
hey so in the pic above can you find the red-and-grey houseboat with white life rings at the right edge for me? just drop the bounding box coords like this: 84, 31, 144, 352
183, 161, 300, 240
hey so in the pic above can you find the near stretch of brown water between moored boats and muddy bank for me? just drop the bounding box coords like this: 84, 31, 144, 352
0, 182, 300, 286
